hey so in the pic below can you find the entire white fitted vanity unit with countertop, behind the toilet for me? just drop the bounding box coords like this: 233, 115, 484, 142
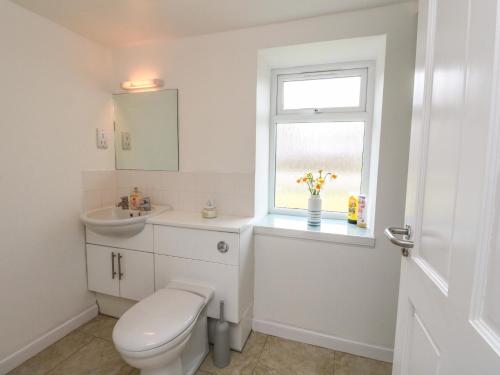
86, 211, 254, 350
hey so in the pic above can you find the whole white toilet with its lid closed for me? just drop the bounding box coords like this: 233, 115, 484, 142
113, 282, 214, 375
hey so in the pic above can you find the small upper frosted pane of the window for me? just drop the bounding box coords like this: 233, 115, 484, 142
283, 76, 361, 110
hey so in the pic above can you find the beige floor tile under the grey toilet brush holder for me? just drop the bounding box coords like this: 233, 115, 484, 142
201, 332, 267, 375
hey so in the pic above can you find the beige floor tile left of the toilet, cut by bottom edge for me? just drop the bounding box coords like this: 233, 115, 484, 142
50, 338, 133, 375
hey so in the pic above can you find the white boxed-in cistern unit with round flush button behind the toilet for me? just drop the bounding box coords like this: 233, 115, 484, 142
154, 225, 253, 324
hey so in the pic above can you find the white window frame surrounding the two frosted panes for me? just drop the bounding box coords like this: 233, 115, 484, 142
268, 61, 375, 219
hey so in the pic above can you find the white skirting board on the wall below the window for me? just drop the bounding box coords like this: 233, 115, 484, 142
252, 319, 393, 362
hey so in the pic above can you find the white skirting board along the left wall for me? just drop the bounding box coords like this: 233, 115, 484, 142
0, 305, 99, 375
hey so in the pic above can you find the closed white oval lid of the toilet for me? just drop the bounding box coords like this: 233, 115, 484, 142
113, 289, 205, 352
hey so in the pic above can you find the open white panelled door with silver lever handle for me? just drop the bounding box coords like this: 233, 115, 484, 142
392, 0, 500, 375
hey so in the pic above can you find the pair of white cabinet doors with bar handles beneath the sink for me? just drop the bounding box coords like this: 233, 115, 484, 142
87, 244, 154, 301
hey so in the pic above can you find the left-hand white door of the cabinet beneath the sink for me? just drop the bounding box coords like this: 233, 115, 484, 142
87, 244, 120, 296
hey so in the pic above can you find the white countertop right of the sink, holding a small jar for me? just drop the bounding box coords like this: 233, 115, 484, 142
147, 210, 254, 233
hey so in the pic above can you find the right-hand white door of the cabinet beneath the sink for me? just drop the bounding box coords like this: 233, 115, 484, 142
117, 249, 154, 301
